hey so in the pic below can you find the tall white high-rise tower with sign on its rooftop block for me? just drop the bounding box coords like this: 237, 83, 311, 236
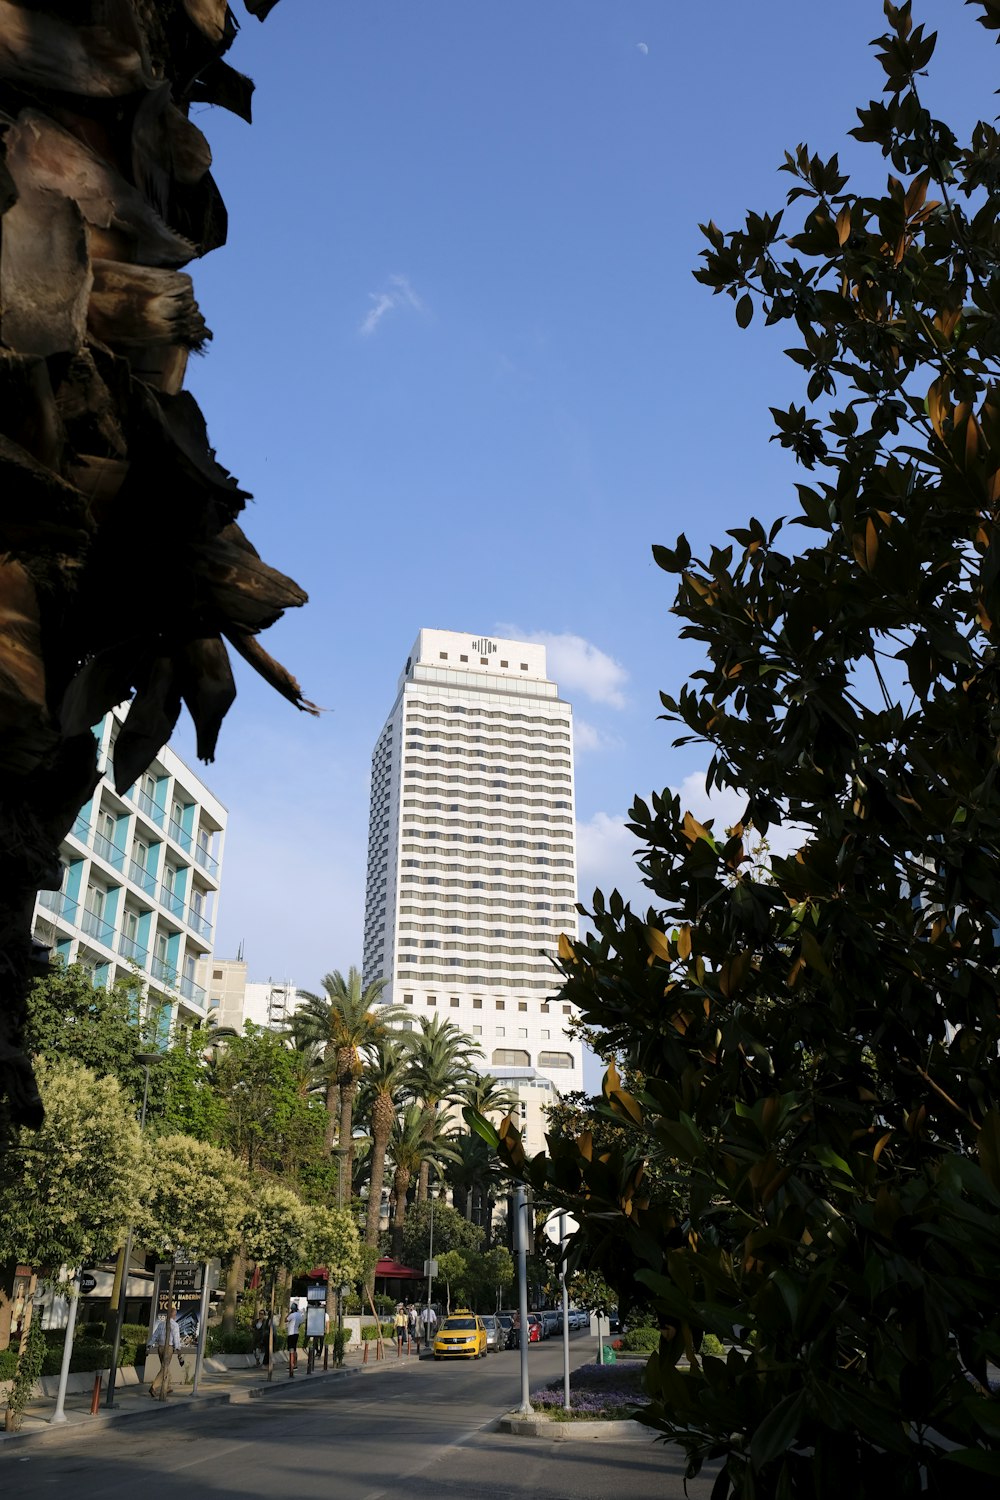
364, 630, 583, 1094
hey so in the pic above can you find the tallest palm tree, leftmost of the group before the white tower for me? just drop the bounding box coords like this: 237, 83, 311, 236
294, 965, 400, 1184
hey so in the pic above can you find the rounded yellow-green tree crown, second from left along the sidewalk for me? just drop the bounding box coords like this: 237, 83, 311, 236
136, 1136, 249, 1260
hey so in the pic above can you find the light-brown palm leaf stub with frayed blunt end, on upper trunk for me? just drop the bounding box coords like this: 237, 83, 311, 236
87, 261, 211, 350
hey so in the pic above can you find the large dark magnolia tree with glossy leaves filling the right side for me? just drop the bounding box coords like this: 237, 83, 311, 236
491, 0, 1000, 1500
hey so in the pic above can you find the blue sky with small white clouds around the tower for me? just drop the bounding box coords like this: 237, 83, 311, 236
175, 0, 999, 1038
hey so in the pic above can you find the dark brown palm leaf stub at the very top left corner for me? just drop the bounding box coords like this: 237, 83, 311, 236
0, 0, 151, 98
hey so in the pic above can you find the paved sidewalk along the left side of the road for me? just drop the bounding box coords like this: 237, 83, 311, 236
0, 1343, 429, 1446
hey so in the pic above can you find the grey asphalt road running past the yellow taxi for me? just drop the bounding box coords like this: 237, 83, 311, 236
0, 1338, 711, 1500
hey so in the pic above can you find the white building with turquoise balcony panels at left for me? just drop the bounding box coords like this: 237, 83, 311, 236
33, 710, 226, 1034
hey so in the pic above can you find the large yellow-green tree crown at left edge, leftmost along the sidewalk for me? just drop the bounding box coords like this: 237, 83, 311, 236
0, 1059, 147, 1271
